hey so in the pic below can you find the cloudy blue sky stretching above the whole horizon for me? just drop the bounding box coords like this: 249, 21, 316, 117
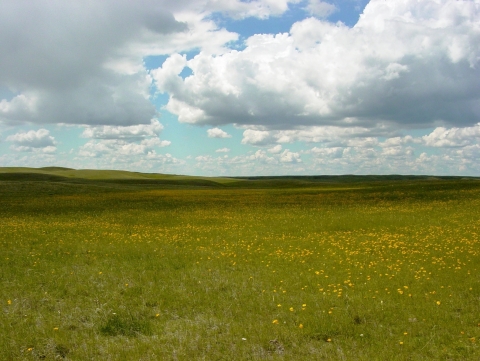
0, 0, 480, 176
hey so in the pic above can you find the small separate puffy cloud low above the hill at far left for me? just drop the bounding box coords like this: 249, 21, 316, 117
6, 129, 57, 153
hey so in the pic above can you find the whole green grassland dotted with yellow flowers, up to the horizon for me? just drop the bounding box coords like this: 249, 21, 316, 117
0, 168, 480, 361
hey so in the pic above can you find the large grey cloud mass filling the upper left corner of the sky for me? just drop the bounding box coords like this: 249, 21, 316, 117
0, 0, 308, 126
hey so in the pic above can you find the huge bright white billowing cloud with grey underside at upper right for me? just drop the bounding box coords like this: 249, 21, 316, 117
152, 0, 480, 129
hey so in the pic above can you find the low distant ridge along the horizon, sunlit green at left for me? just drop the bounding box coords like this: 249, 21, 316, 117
0, 167, 480, 188
